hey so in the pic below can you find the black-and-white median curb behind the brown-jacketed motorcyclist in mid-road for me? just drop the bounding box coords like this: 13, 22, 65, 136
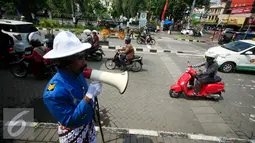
101, 45, 199, 54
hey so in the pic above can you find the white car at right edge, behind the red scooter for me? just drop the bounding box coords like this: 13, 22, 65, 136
205, 40, 255, 73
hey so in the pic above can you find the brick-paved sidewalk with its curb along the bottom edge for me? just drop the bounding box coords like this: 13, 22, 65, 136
0, 124, 255, 143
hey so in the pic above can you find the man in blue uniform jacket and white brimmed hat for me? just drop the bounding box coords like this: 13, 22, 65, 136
43, 31, 102, 143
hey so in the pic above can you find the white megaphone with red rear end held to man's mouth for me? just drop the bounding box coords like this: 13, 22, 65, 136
83, 68, 128, 94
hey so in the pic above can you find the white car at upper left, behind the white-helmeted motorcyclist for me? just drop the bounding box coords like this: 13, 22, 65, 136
0, 19, 41, 53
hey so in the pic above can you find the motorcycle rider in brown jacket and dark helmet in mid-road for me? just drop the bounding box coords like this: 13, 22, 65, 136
120, 37, 135, 68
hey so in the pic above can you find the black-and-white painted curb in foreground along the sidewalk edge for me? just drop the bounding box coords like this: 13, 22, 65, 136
6, 122, 255, 143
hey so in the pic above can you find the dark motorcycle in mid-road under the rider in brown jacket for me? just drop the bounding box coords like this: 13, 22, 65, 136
105, 51, 143, 72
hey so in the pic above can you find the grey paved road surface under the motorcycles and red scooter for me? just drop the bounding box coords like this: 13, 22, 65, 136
0, 32, 255, 138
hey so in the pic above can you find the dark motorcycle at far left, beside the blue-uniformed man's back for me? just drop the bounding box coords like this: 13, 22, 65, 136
10, 47, 57, 78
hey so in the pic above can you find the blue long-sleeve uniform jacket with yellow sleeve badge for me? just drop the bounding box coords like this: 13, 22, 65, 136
43, 70, 94, 128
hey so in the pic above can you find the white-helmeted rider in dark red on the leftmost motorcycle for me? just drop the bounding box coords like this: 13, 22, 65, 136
24, 32, 47, 79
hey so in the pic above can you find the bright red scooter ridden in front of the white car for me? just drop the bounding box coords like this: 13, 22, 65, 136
169, 62, 225, 100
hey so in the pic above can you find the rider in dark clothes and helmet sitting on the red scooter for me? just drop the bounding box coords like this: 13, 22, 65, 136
192, 53, 218, 96
